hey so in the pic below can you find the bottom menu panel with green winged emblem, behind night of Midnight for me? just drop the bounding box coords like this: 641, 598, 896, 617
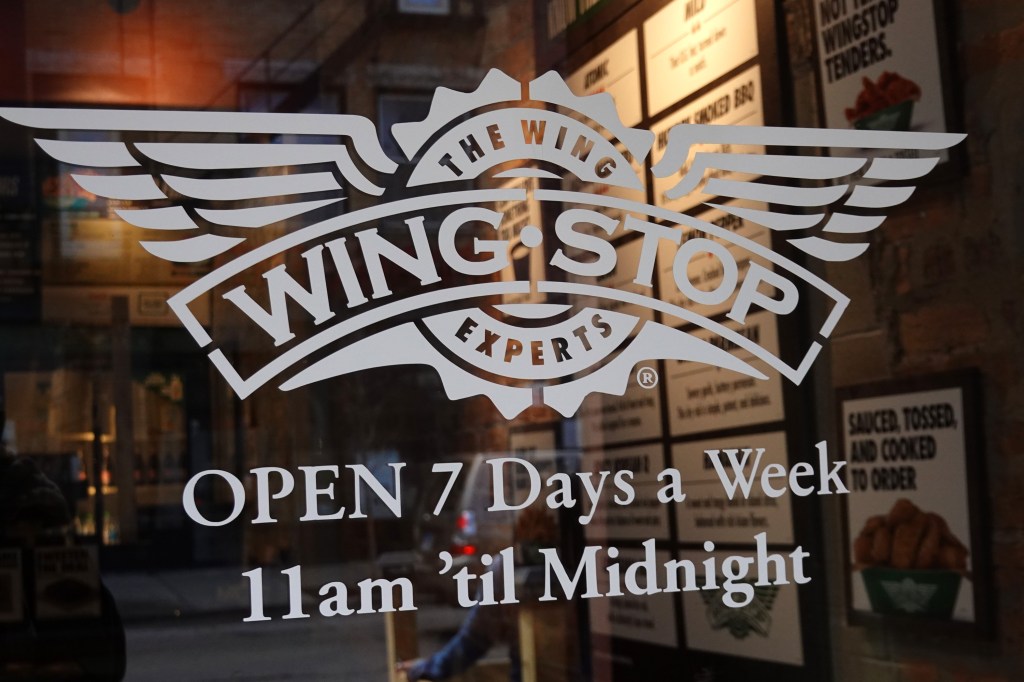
679, 551, 804, 666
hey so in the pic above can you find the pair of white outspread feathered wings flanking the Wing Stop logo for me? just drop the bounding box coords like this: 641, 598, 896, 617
0, 99, 965, 262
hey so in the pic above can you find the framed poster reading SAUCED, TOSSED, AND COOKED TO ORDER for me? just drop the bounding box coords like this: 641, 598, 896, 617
839, 373, 989, 631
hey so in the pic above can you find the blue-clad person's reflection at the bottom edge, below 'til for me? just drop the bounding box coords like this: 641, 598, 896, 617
398, 557, 520, 682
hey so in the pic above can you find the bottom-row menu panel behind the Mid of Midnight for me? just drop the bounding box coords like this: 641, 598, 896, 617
587, 549, 678, 647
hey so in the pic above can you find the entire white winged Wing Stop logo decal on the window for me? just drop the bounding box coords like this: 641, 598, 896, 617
0, 71, 964, 419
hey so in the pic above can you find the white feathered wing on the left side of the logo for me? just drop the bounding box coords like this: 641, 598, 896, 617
0, 108, 397, 262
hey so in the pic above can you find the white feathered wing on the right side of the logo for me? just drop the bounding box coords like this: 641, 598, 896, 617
652, 124, 966, 261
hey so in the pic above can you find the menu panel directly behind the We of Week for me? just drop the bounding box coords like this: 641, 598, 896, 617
672, 431, 794, 544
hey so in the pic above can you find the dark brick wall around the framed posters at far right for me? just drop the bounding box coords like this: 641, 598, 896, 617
786, 0, 1024, 682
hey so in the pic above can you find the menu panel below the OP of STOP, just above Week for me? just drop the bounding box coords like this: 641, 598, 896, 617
666, 311, 784, 436
